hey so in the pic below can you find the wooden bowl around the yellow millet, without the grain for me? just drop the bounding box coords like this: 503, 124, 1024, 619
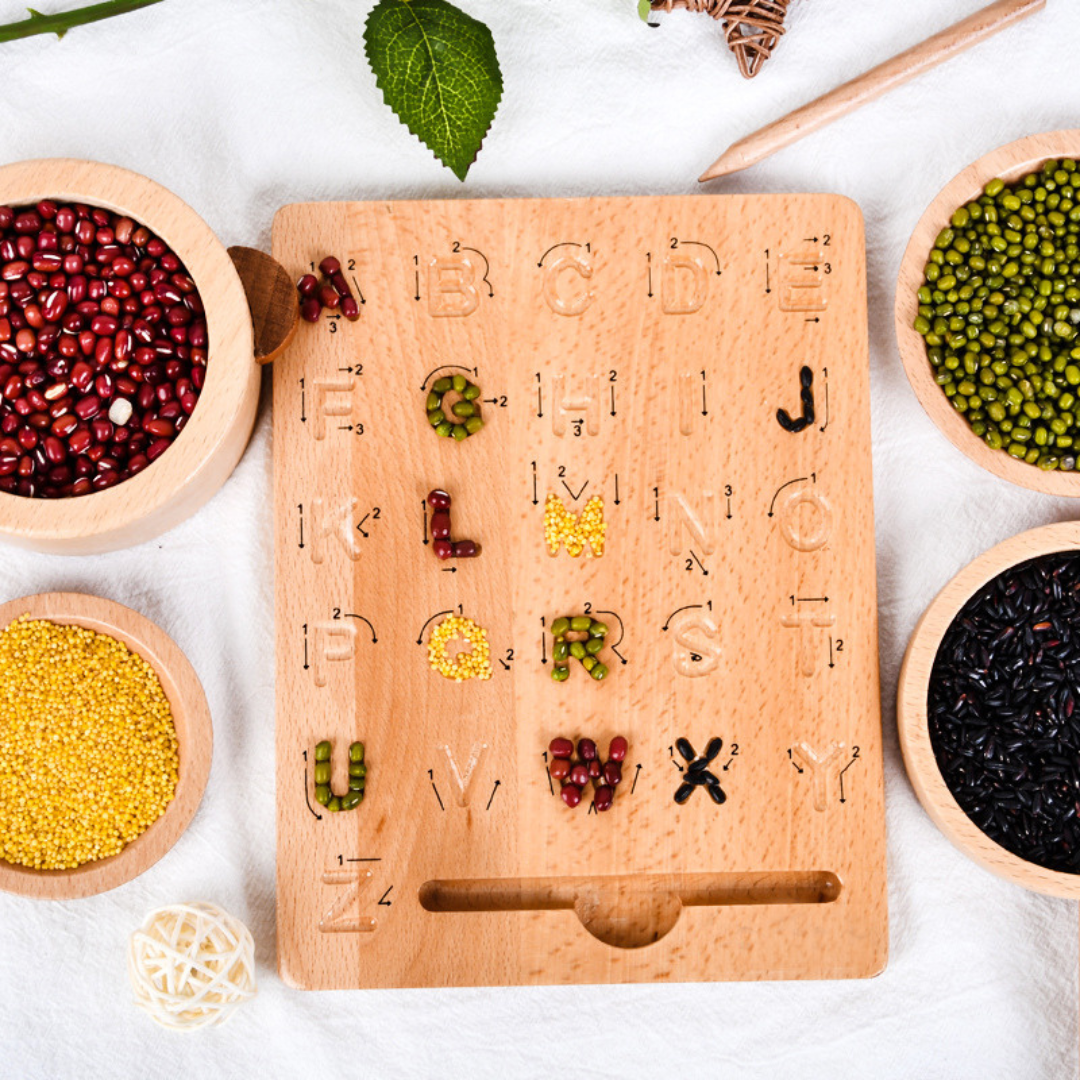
0, 593, 214, 900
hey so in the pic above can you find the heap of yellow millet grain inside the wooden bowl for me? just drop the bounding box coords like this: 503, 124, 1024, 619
0, 616, 179, 869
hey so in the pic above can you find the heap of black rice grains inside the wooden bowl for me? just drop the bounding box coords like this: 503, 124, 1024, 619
927, 552, 1080, 874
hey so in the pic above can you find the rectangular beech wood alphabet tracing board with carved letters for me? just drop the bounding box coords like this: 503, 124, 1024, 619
273, 194, 888, 988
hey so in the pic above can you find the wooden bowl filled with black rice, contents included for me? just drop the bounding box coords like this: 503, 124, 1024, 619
896, 522, 1080, 900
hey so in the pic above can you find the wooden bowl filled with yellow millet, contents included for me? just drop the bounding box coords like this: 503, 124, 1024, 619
0, 593, 213, 900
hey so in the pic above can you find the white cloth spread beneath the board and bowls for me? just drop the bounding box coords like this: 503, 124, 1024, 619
0, 0, 1080, 1080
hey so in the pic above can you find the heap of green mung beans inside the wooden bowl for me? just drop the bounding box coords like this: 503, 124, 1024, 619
914, 159, 1080, 471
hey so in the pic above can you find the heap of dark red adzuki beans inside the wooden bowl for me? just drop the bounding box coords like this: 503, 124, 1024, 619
0, 200, 206, 498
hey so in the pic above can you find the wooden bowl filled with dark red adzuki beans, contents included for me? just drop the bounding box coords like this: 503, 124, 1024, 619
0, 160, 260, 553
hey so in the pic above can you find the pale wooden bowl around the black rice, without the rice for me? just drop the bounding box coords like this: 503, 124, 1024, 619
896, 522, 1080, 900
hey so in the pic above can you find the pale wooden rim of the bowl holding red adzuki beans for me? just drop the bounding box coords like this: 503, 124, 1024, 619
0, 158, 255, 545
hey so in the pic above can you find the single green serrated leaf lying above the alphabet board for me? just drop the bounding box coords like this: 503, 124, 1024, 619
364, 0, 502, 180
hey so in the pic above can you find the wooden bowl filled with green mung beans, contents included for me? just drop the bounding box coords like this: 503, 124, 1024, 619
895, 130, 1080, 497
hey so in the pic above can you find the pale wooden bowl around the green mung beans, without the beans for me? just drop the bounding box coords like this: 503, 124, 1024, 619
895, 129, 1080, 497
